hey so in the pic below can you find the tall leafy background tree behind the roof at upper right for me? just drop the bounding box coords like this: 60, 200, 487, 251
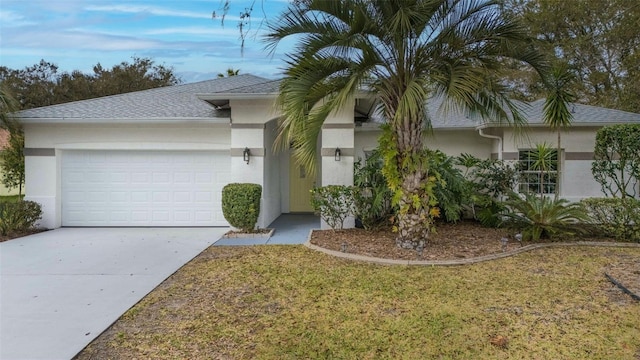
506, 0, 640, 112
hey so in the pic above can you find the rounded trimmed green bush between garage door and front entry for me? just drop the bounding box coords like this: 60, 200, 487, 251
222, 183, 262, 232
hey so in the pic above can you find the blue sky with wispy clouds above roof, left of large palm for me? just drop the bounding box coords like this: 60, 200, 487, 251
0, 0, 288, 82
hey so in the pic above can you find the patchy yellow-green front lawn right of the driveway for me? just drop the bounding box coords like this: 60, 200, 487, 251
77, 246, 640, 359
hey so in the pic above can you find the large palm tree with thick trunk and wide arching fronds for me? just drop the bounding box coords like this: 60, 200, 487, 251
266, 0, 542, 248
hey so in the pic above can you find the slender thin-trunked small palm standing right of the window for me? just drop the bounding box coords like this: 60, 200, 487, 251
542, 63, 576, 199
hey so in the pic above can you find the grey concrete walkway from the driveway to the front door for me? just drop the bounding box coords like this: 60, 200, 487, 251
214, 214, 320, 246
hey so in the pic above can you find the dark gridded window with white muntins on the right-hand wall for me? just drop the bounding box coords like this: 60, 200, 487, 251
518, 149, 558, 194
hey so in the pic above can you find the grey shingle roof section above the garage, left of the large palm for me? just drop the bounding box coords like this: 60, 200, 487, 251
16, 74, 273, 120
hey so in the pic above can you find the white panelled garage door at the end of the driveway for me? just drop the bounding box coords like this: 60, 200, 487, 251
61, 150, 231, 226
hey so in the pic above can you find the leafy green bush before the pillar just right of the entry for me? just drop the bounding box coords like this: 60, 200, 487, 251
311, 185, 355, 230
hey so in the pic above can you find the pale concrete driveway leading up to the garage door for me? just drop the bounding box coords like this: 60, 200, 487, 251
0, 228, 228, 360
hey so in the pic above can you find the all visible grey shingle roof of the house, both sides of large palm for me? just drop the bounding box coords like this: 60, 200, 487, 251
16, 74, 640, 129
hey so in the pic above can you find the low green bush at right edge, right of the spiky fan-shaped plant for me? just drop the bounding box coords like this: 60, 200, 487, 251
582, 198, 640, 242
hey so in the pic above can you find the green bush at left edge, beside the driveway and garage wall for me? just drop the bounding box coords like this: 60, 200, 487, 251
0, 201, 42, 235
